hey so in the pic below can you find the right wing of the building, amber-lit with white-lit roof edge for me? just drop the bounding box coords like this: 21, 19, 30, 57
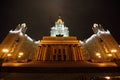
82, 24, 120, 62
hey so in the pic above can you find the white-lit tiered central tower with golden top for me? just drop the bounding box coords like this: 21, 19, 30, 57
50, 17, 69, 37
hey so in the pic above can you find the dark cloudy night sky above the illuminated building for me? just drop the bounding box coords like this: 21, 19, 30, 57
0, 0, 120, 43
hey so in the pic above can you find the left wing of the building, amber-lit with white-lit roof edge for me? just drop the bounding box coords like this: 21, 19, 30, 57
0, 23, 37, 60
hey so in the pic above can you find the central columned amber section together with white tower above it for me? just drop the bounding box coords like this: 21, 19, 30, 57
35, 19, 83, 61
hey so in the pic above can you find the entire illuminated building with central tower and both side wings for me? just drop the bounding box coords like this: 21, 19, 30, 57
0, 18, 120, 62
